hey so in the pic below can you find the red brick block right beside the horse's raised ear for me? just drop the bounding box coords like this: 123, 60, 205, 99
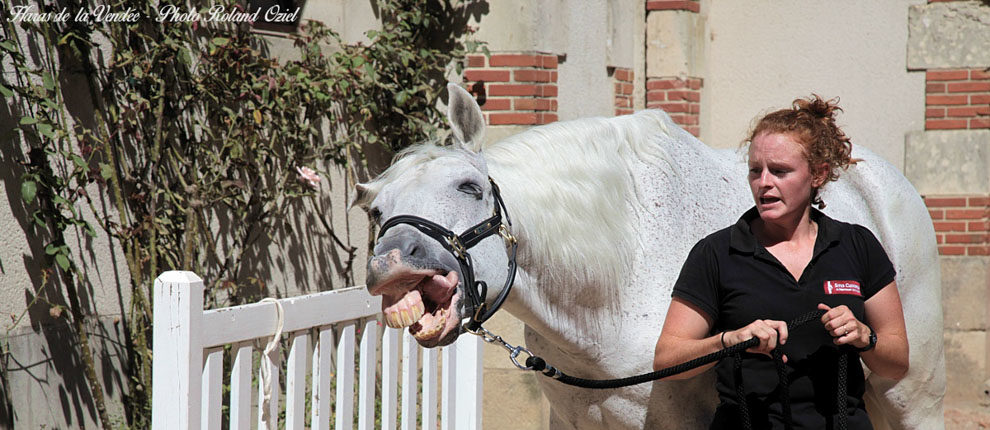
464, 52, 557, 125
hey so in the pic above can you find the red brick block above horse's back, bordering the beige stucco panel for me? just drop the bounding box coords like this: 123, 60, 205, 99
646, 77, 703, 136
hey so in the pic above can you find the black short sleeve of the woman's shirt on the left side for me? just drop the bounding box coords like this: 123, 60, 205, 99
671, 238, 719, 321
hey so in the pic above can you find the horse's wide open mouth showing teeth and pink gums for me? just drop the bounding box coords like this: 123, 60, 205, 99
371, 270, 459, 343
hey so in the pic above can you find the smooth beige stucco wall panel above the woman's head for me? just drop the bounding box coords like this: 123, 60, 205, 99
701, 0, 925, 168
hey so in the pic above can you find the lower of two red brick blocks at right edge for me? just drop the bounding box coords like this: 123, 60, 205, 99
925, 195, 990, 256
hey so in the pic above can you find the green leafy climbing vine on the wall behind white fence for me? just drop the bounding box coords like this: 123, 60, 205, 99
0, 0, 479, 428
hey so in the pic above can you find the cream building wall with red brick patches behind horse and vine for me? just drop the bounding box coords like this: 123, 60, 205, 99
0, 0, 990, 429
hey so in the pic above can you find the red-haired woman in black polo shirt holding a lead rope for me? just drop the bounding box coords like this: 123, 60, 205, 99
653, 96, 908, 429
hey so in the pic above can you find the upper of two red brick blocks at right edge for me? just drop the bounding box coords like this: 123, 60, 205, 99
925, 69, 990, 130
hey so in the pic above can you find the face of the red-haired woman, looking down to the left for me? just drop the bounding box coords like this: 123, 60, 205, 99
749, 133, 821, 222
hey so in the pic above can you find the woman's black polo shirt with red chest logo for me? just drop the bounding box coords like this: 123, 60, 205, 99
673, 207, 895, 429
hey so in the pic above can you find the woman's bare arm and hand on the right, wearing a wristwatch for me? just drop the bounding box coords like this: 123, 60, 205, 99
818, 282, 909, 379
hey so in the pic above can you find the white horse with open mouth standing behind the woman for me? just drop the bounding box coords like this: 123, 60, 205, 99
357, 85, 945, 429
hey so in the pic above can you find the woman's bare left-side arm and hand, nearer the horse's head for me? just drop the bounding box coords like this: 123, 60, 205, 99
653, 297, 787, 379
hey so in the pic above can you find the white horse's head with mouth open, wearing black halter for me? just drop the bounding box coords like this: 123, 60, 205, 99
357, 84, 509, 347
